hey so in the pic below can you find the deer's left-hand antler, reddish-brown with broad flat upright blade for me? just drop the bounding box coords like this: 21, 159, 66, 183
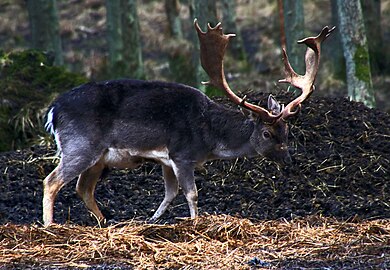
194, 19, 281, 123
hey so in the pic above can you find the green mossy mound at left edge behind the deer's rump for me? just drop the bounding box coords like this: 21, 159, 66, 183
0, 50, 87, 151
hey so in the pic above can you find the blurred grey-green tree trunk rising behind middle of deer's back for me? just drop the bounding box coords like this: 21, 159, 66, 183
106, 0, 145, 79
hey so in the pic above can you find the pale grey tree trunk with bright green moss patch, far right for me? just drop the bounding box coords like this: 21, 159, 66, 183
337, 0, 375, 107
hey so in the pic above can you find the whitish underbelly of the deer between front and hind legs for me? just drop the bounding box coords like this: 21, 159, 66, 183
103, 147, 171, 169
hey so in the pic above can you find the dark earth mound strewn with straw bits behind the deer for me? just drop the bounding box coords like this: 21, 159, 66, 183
0, 94, 390, 225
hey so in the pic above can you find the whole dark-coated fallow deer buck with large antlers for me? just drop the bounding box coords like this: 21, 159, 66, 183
43, 20, 333, 226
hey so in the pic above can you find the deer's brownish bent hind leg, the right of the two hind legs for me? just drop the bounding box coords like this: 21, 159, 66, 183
76, 162, 104, 222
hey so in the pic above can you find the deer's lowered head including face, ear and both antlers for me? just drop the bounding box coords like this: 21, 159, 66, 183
194, 19, 334, 163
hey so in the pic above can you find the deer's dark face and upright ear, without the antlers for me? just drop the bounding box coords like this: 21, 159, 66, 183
250, 96, 291, 164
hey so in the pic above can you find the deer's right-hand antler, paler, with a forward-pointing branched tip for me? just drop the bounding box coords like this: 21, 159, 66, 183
279, 26, 335, 118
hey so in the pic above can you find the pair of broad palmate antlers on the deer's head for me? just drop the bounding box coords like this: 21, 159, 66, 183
194, 19, 334, 124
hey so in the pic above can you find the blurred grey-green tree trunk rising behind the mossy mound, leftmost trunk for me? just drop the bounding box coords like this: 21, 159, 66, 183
27, 0, 64, 65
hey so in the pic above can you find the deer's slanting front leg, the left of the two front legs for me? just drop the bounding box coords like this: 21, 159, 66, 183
150, 165, 179, 222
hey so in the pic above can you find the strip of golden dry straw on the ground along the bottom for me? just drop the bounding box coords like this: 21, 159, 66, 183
0, 215, 390, 269
